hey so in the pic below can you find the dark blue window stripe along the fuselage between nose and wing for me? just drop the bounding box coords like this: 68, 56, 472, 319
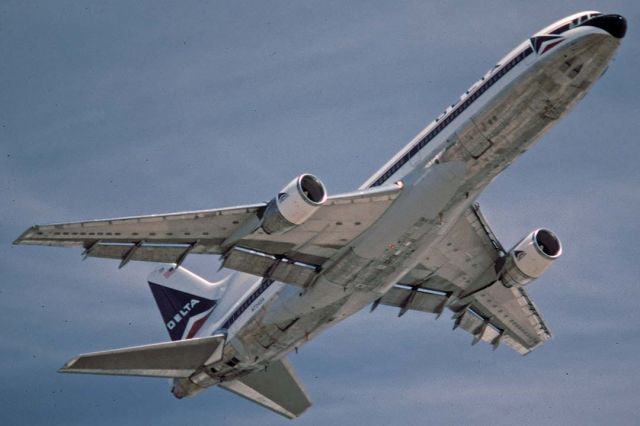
371, 46, 533, 187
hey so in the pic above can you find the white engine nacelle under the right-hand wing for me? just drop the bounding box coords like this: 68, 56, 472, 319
499, 229, 562, 287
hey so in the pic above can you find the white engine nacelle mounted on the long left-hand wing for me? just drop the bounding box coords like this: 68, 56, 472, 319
262, 174, 327, 234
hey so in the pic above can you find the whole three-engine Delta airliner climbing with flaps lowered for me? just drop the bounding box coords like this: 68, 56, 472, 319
14, 11, 627, 418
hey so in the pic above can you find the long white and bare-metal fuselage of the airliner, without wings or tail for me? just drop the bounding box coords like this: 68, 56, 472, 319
174, 12, 619, 392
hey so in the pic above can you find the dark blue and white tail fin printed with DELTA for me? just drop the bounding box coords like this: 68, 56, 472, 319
147, 265, 223, 340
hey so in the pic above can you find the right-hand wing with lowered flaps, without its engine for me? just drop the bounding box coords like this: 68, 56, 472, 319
374, 205, 551, 355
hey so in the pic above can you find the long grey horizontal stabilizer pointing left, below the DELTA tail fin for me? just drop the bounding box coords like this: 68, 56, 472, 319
59, 335, 225, 378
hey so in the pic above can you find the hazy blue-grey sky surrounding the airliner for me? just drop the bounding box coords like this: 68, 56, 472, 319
0, 0, 640, 425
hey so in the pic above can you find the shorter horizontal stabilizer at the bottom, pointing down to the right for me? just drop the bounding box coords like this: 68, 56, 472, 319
220, 358, 311, 419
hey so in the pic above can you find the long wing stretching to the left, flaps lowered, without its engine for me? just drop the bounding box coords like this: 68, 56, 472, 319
14, 185, 401, 275
